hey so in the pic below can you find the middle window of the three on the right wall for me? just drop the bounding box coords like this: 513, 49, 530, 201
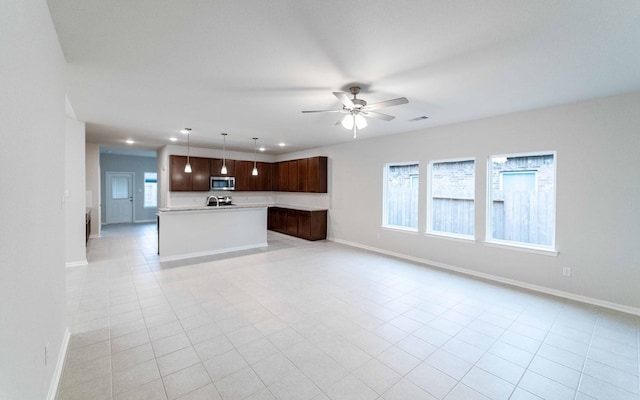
427, 160, 476, 238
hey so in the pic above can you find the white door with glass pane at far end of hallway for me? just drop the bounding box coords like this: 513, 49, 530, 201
107, 172, 133, 224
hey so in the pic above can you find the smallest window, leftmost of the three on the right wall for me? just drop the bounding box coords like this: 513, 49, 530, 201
382, 163, 419, 231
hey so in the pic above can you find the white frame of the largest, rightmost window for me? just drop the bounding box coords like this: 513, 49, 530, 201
484, 150, 558, 255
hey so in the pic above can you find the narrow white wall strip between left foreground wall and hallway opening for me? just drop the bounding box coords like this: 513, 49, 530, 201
64, 117, 87, 266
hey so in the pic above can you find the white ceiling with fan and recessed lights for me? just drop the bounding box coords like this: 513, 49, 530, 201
47, 0, 640, 154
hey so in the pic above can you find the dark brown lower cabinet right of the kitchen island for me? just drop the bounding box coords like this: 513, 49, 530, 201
267, 207, 327, 240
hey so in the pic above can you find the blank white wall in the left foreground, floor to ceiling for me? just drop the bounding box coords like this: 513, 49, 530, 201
0, 0, 66, 400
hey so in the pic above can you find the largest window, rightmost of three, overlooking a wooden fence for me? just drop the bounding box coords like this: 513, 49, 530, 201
487, 153, 556, 249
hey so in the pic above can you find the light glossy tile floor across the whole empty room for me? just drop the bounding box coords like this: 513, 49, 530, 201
58, 224, 640, 400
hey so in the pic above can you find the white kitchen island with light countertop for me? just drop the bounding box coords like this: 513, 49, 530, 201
157, 205, 267, 261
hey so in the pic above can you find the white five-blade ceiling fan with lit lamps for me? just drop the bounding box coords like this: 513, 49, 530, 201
303, 86, 409, 139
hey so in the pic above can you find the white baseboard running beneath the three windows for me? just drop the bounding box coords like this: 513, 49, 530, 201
331, 238, 640, 316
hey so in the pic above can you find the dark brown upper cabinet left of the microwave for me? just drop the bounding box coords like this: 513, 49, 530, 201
169, 156, 210, 192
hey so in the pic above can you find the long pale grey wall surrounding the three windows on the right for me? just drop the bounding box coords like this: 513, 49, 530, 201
286, 92, 640, 312
